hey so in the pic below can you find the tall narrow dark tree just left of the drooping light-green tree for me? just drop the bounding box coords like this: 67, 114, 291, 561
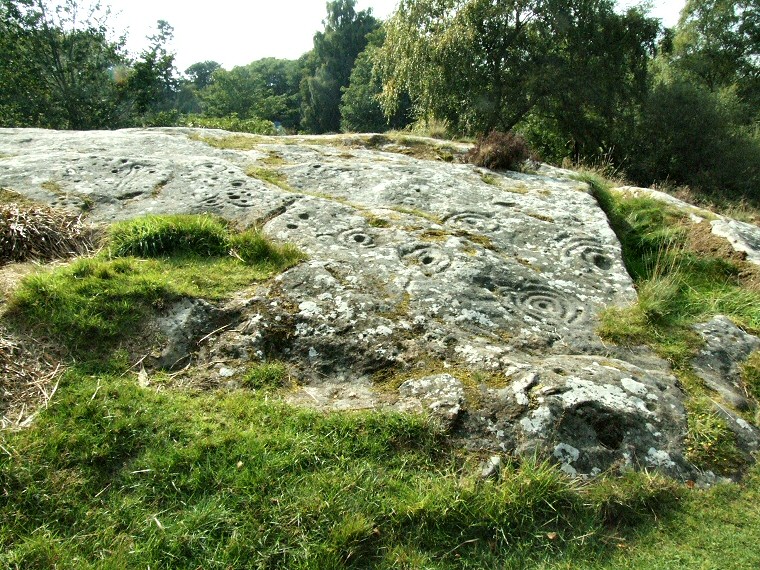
301, 0, 379, 133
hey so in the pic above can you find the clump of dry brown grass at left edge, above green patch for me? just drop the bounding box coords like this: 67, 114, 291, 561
0, 202, 93, 265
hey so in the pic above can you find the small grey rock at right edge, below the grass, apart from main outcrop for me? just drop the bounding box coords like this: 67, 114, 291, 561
692, 315, 760, 410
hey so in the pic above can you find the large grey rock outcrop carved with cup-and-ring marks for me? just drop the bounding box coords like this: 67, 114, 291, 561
0, 129, 754, 478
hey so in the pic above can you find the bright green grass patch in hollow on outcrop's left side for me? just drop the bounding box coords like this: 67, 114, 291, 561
8, 216, 303, 359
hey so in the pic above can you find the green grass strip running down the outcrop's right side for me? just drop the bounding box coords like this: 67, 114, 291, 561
579, 174, 760, 474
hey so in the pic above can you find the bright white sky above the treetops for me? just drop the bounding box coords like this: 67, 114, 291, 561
103, 0, 685, 71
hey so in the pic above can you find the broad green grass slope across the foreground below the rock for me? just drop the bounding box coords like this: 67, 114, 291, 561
0, 192, 760, 568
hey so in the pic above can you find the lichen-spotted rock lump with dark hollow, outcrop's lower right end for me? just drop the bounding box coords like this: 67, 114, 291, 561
465, 355, 691, 477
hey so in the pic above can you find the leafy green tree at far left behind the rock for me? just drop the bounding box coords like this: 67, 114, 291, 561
0, 0, 125, 129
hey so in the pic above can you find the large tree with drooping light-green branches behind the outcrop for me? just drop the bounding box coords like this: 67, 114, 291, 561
378, 0, 657, 139
